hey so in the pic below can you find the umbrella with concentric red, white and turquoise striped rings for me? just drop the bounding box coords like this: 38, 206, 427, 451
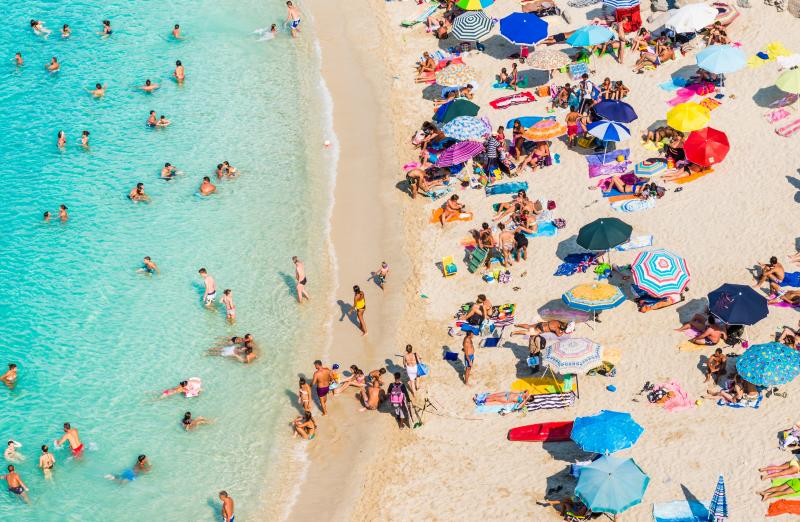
631, 249, 691, 297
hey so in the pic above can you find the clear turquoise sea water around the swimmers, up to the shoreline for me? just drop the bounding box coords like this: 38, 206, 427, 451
0, 0, 327, 521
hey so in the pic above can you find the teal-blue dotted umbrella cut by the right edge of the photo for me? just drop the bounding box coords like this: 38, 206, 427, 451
736, 341, 800, 386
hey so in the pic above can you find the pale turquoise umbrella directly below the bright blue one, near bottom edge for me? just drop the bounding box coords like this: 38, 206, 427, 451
575, 455, 650, 515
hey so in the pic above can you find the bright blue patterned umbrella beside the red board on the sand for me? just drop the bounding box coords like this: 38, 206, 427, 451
570, 410, 644, 455
